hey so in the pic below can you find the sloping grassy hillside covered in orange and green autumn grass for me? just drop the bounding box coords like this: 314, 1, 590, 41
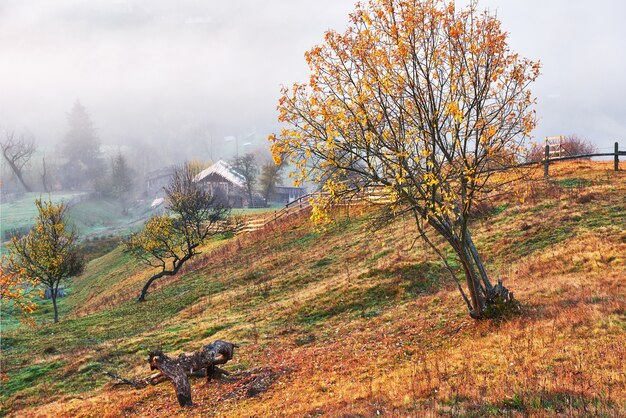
0, 162, 626, 417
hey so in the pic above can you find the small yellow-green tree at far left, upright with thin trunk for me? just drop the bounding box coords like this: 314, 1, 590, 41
9, 198, 85, 322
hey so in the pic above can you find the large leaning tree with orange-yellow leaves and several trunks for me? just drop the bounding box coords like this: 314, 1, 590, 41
270, 0, 539, 318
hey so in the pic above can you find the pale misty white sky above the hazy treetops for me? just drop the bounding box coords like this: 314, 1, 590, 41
0, 0, 626, 162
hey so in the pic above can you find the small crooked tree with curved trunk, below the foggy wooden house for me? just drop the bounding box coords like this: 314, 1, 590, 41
125, 164, 231, 302
